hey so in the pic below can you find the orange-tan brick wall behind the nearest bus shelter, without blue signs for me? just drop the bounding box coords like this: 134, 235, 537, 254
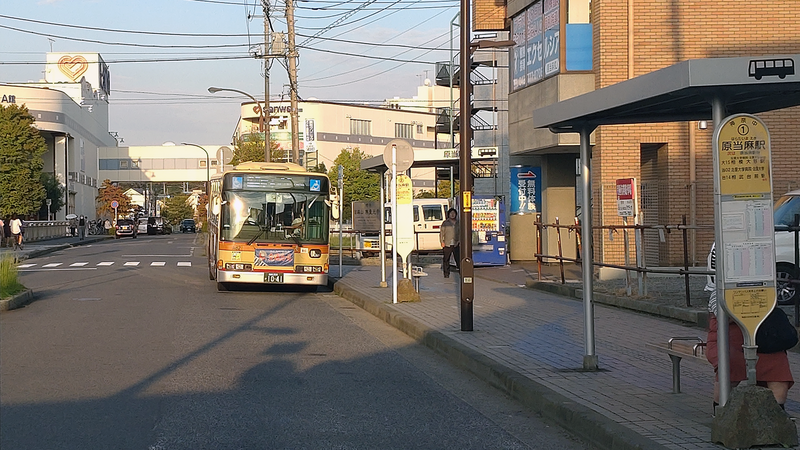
592, 0, 800, 265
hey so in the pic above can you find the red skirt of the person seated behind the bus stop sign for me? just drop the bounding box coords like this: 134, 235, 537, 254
706, 314, 794, 387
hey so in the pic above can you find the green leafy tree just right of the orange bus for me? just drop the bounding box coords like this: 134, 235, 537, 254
328, 147, 381, 220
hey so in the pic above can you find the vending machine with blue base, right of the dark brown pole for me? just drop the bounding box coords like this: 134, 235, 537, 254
472, 196, 506, 266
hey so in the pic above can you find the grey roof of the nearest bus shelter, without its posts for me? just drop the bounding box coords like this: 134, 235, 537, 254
533, 54, 800, 133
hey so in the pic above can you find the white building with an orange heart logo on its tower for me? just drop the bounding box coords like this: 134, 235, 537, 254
0, 53, 117, 220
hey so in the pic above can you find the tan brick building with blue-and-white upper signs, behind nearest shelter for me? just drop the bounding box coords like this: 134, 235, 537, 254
506, 0, 800, 266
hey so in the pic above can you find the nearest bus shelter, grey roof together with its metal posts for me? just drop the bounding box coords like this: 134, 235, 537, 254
532, 54, 800, 405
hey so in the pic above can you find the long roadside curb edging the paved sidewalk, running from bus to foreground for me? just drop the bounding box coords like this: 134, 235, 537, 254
333, 280, 667, 450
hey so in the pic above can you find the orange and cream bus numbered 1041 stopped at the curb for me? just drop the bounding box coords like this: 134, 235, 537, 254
208, 162, 338, 291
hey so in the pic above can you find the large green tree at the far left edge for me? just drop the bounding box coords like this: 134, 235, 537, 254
0, 105, 47, 216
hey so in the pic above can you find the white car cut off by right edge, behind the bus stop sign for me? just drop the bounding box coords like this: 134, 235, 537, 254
773, 190, 800, 305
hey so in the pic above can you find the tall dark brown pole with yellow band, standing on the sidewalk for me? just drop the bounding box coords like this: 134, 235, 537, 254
460, 0, 475, 331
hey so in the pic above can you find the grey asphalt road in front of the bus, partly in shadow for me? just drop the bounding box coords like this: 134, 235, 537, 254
0, 234, 590, 450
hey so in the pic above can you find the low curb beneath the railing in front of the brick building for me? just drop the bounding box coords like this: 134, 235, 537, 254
525, 279, 708, 328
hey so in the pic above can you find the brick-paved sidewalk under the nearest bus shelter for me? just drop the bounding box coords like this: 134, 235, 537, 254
334, 266, 800, 450
